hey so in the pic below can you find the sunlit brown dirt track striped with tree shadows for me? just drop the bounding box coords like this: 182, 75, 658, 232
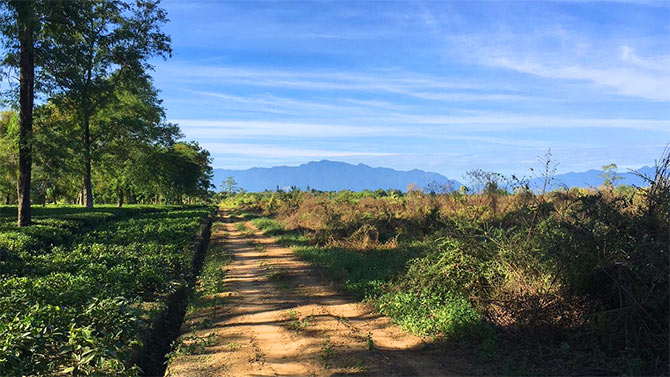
168, 216, 472, 376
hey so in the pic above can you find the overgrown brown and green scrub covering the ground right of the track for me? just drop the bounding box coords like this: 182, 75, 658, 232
223, 152, 670, 375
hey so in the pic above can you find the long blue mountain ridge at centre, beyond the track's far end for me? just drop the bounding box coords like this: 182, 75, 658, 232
214, 160, 461, 192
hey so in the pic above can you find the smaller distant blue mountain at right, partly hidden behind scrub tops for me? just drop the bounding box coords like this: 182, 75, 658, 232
530, 166, 654, 190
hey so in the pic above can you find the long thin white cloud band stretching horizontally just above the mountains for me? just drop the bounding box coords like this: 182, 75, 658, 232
171, 114, 670, 140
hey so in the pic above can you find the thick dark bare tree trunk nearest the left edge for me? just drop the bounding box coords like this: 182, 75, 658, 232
16, 1, 35, 227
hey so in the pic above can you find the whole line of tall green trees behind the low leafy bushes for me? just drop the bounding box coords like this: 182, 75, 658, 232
0, 0, 212, 226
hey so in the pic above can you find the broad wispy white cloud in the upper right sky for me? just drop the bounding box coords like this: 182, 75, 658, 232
444, 26, 670, 102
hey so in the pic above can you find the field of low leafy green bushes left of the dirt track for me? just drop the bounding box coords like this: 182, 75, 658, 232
0, 206, 213, 376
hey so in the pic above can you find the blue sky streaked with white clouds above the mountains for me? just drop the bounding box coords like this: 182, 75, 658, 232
155, 0, 670, 178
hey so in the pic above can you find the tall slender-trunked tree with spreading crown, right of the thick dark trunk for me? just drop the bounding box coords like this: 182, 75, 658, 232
43, 0, 171, 208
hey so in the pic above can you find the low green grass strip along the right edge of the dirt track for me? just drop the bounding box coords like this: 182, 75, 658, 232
240, 212, 497, 360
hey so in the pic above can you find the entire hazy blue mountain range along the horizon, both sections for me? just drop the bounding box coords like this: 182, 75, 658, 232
213, 160, 654, 192
